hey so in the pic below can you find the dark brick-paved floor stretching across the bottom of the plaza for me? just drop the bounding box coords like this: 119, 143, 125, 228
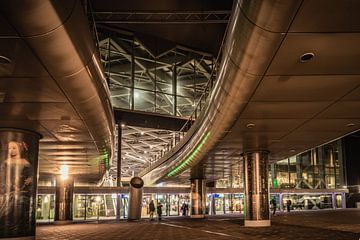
36, 209, 360, 240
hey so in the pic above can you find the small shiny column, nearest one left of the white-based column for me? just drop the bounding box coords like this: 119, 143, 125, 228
190, 179, 206, 218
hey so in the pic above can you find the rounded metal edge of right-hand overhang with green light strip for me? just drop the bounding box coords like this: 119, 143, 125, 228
141, 1, 300, 184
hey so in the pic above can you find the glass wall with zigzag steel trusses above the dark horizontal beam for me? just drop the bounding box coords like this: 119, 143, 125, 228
99, 33, 216, 117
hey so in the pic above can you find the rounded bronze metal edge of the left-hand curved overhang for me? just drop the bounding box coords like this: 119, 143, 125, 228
0, 0, 114, 176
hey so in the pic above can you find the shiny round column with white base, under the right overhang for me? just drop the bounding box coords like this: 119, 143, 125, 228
244, 151, 270, 227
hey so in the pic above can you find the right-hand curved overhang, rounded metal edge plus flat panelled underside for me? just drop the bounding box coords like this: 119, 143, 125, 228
141, 0, 360, 184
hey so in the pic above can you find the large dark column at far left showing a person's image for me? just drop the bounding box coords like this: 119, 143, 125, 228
0, 128, 40, 239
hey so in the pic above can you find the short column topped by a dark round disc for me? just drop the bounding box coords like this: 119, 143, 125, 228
128, 177, 144, 220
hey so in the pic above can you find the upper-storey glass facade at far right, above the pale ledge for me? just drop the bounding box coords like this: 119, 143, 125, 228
269, 140, 345, 189
